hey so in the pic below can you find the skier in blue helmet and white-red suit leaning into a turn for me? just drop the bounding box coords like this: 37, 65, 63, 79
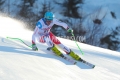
32, 12, 81, 61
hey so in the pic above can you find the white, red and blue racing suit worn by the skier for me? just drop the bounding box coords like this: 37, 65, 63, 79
32, 18, 70, 53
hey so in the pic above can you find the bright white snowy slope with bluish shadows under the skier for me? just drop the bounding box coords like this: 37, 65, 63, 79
0, 17, 120, 80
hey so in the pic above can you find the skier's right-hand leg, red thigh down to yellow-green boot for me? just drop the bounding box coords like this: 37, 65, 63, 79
50, 33, 81, 60
